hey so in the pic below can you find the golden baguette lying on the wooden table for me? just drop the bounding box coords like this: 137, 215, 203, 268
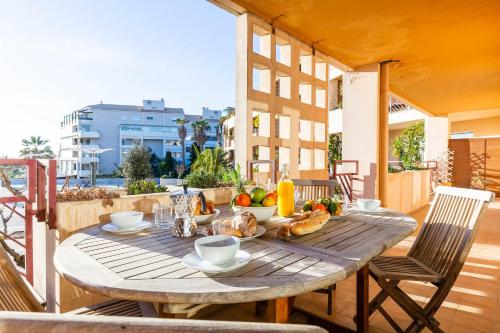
276, 210, 331, 239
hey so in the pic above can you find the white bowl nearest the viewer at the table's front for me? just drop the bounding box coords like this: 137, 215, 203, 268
194, 235, 240, 265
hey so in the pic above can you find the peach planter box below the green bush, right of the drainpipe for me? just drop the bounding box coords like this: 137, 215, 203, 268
385, 170, 431, 214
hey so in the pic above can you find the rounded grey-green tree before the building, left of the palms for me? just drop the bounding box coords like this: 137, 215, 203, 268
122, 146, 153, 184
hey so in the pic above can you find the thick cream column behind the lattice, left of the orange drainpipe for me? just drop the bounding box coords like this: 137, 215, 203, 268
342, 64, 380, 198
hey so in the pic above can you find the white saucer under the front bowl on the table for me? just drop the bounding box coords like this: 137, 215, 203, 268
182, 250, 250, 273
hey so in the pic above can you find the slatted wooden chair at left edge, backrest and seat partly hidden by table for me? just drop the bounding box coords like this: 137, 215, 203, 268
0, 246, 156, 317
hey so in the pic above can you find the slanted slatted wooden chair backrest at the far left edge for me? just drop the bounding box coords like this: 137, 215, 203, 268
0, 245, 44, 312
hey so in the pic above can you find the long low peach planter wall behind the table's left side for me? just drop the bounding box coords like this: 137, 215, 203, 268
33, 187, 240, 312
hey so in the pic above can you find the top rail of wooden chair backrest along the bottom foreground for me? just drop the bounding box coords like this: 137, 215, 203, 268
0, 312, 326, 333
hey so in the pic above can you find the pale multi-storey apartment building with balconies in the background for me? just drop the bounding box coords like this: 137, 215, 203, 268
59, 99, 221, 177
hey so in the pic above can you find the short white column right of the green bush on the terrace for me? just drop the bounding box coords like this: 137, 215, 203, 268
424, 117, 449, 161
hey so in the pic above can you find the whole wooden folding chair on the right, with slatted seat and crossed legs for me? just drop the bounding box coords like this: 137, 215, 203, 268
369, 186, 495, 332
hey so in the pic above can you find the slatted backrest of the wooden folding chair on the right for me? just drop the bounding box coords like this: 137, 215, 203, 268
408, 186, 495, 279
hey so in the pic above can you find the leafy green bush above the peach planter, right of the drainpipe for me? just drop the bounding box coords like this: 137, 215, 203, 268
392, 121, 425, 170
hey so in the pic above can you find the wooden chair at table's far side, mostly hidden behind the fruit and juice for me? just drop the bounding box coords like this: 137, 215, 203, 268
292, 179, 341, 315
